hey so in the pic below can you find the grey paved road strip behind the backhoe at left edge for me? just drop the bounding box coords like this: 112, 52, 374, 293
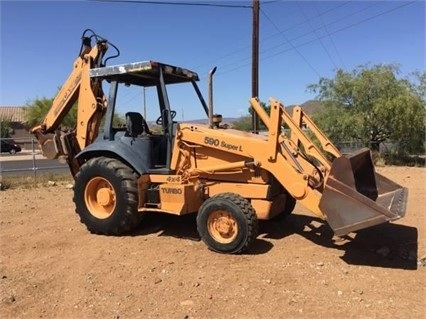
0, 152, 68, 175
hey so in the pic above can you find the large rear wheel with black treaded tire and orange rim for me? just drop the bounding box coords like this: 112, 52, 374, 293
74, 157, 143, 235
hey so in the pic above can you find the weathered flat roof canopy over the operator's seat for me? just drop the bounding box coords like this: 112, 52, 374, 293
90, 61, 199, 87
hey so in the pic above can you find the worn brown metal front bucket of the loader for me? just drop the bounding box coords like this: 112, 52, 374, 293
319, 148, 408, 236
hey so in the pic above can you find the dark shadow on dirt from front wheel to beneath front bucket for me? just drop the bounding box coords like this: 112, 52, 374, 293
261, 214, 418, 270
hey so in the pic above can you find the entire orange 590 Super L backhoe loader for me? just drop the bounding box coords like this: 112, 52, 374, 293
32, 29, 408, 254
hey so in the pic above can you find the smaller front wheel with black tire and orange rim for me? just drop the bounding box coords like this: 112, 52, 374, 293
197, 193, 258, 254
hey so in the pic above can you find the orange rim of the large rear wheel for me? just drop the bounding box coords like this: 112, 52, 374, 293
84, 176, 116, 219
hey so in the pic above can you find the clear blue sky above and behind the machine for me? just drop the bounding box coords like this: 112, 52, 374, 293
0, 0, 426, 120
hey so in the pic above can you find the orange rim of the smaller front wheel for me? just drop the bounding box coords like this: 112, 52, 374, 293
207, 210, 238, 244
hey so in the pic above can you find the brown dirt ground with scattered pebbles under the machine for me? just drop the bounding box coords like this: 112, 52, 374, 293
0, 167, 426, 319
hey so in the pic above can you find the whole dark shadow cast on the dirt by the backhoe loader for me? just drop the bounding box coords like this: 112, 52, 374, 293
129, 213, 418, 270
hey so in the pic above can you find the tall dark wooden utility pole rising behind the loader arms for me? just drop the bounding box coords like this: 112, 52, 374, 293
251, 0, 259, 134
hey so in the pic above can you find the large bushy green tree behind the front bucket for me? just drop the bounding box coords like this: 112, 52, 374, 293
308, 64, 426, 153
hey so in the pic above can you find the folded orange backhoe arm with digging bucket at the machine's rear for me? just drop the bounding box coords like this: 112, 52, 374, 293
31, 32, 108, 175
